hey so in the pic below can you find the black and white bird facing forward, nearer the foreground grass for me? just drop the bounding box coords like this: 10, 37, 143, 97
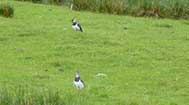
74, 71, 84, 89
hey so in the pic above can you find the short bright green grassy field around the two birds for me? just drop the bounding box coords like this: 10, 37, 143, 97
0, 2, 189, 105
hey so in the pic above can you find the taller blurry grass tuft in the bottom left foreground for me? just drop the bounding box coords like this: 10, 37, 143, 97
0, 86, 64, 105
